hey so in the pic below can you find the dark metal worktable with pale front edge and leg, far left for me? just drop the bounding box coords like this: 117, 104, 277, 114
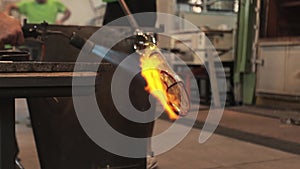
0, 62, 101, 169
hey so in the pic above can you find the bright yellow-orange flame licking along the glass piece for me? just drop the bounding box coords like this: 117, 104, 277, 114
140, 47, 179, 120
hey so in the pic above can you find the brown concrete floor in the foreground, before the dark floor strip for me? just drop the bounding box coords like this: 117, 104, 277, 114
156, 120, 300, 169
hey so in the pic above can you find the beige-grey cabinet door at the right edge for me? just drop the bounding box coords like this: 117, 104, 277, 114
256, 42, 300, 96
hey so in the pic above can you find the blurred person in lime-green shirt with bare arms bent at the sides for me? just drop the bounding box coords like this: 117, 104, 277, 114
5, 0, 71, 24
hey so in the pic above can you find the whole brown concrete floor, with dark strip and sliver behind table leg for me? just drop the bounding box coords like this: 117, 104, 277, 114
16, 100, 300, 169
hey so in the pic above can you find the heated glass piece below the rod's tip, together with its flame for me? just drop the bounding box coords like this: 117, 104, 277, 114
137, 34, 190, 120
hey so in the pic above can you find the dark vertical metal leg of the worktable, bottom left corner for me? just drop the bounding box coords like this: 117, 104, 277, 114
0, 98, 17, 169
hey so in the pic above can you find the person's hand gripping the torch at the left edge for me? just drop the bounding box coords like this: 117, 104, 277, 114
0, 12, 24, 48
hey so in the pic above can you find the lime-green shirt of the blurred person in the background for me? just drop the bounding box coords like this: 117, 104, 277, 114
17, 0, 66, 24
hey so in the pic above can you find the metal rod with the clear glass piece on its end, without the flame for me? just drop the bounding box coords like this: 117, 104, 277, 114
115, 0, 190, 119
